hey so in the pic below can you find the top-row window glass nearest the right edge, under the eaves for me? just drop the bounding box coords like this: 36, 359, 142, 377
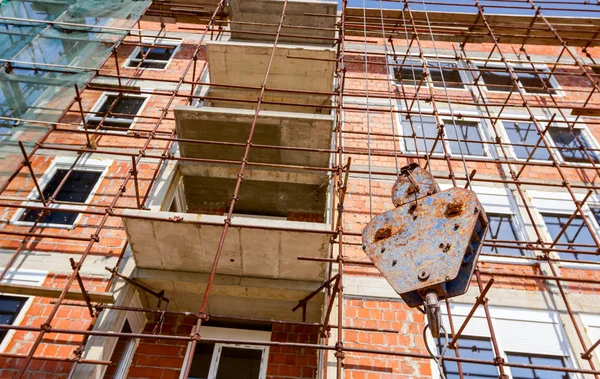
477, 66, 556, 94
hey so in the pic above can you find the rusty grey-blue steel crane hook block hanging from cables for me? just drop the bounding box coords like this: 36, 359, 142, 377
362, 163, 488, 338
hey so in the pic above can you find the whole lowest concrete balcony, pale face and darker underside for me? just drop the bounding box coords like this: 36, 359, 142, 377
123, 210, 330, 321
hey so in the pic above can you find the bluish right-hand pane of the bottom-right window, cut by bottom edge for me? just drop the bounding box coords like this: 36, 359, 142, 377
506, 353, 569, 379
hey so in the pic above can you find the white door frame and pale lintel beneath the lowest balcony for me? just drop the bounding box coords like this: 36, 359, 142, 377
179, 326, 271, 379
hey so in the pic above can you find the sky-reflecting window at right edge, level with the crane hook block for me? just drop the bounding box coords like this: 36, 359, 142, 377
542, 214, 600, 262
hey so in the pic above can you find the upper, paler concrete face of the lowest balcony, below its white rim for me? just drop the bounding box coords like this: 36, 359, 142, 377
123, 210, 330, 282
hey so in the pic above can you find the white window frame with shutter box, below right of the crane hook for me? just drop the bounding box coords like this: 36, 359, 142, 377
434, 302, 581, 379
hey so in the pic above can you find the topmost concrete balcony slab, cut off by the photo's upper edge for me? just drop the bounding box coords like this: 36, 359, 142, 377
230, 0, 337, 45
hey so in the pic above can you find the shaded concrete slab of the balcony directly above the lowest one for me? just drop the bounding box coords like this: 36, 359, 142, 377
175, 106, 334, 167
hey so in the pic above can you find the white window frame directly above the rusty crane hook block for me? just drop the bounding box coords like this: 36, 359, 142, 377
396, 108, 496, 160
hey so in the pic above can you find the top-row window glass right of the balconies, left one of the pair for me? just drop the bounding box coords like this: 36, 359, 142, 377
394, 62, 465, 88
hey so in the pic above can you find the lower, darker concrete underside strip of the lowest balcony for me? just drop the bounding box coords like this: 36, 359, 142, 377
135, 268, 323, 322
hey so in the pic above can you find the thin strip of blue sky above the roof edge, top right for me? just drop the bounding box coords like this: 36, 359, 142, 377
348, 0, 600, 18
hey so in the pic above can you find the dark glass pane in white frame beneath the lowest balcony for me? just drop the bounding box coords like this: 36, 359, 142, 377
217, 346, 262, 379
